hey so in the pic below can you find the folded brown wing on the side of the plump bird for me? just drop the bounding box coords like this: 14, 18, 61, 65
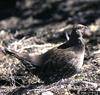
41, 49, 77, 71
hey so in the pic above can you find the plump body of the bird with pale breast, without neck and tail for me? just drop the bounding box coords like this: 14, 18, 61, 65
37, 42, 84, 81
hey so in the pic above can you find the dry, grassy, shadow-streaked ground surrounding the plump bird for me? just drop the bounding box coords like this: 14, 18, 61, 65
0, 0, 100, 95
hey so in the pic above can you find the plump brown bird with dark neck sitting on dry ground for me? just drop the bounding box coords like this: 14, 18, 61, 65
3, 24, 88, 84
